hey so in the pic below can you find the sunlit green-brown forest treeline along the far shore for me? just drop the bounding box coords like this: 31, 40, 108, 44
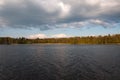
0, 34, 120, 44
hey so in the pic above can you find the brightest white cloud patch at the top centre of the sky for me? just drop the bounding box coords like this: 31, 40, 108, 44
34, 0, 70, 17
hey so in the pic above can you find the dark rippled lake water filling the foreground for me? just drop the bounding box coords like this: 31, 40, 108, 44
0, 44, 120, 80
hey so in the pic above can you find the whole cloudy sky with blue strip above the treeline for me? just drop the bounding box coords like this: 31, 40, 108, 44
0, 0, 120, 38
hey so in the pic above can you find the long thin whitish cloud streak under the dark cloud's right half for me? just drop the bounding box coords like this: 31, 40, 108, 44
35, 19, 118, 30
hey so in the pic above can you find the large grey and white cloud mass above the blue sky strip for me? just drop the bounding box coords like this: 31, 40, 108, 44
0, 0, 120, 30
